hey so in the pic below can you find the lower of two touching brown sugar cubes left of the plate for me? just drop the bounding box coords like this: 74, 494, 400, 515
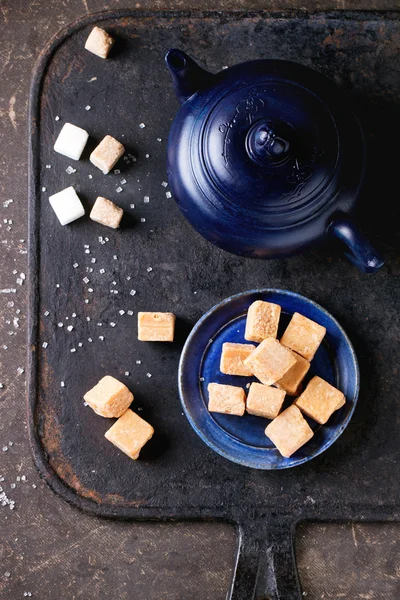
104, 408, 154, 460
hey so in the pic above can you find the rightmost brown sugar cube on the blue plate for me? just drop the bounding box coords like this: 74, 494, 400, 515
295, 377, 346, 425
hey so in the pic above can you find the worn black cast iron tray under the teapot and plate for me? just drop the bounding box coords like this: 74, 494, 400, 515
28, 11, 400, 600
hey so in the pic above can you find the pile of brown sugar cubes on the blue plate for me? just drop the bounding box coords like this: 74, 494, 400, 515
208, 300, 346, 458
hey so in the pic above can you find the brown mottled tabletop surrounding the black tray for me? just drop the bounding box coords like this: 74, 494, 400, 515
0, 0, 400, 600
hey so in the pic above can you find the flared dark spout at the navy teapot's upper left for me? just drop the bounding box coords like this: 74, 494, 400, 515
165, 48, 215, 104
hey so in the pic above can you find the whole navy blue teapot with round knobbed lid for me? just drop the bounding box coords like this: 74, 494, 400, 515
165, 49, 383, 272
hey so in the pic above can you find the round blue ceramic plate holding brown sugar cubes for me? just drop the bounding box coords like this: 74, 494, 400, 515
179, 289, 360, 469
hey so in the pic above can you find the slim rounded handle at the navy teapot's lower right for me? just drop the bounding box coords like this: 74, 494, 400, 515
328, 215, 384, 273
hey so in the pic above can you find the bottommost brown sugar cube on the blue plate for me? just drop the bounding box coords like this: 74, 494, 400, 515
265, 404, 314, 458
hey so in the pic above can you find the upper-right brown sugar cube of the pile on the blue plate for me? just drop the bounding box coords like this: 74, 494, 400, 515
281, 313, 326, 360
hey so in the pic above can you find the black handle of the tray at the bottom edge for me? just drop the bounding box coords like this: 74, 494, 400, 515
227, 516, 302, 600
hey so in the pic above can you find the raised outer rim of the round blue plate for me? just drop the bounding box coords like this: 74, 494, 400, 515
178, 288, 360, 471
